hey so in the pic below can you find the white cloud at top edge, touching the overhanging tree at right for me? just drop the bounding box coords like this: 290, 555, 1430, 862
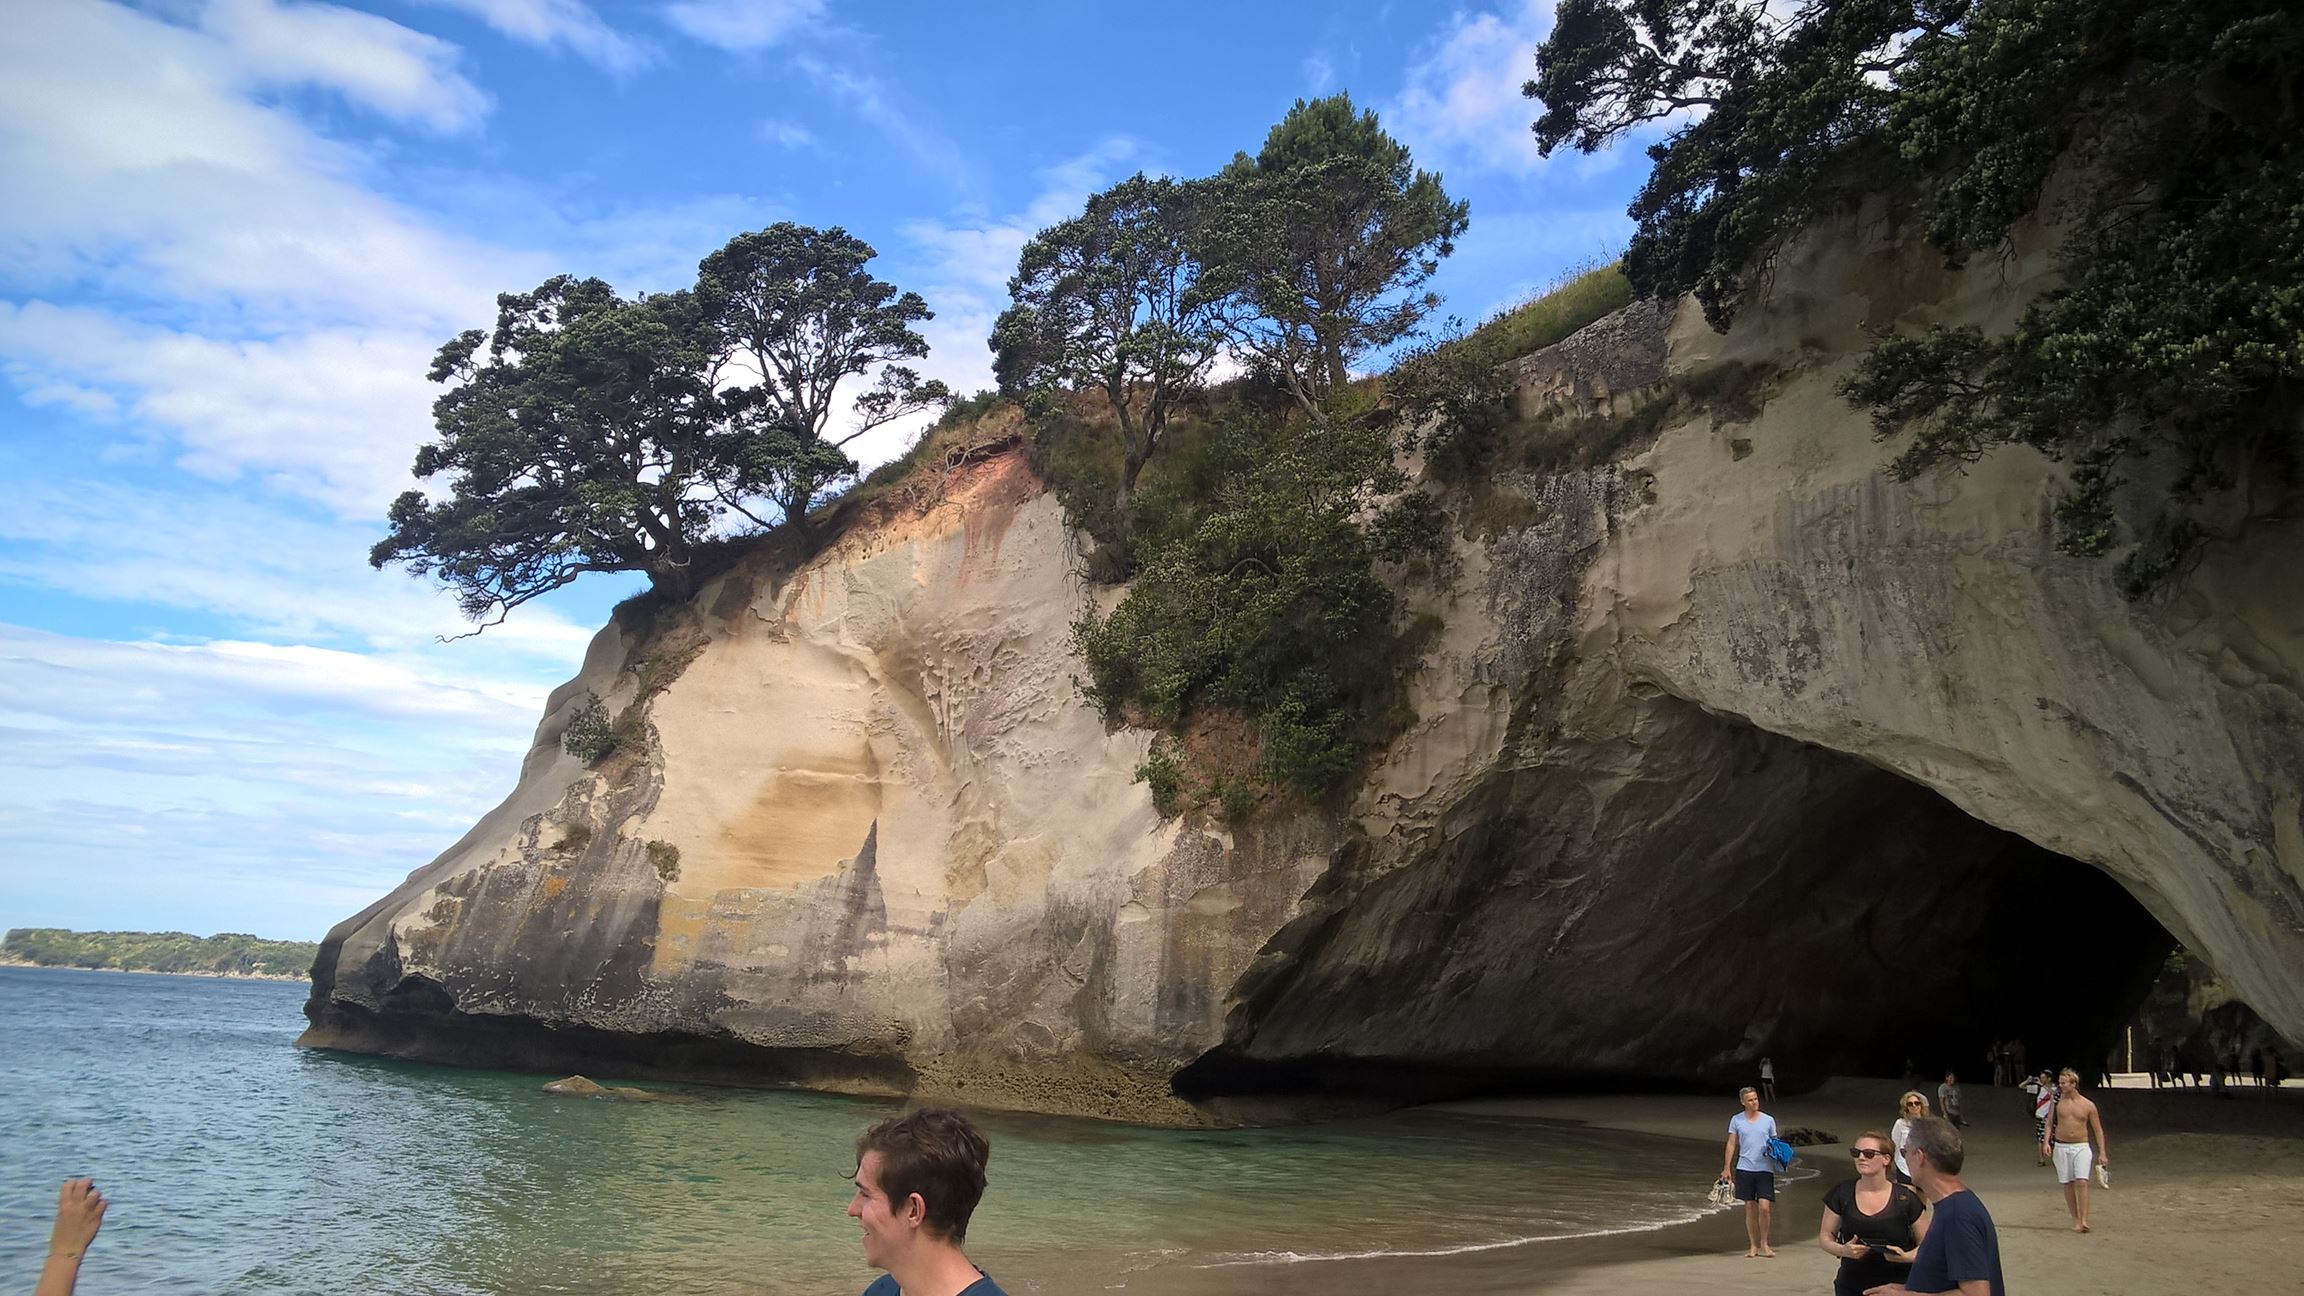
1382, 0, 1553, 175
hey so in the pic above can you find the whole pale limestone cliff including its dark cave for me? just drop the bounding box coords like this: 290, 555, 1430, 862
304, 199, 2304, 1121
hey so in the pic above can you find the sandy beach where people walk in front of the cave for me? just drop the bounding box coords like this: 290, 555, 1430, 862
1437, 1079, 2304, 1296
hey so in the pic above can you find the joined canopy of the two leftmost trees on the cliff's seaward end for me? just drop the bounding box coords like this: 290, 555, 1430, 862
369, 224, 945, 625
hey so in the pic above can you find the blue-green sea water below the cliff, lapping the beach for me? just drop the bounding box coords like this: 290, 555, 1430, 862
0, 969, 1712, 1296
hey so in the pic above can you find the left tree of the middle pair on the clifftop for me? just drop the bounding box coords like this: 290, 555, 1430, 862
991, 173, 1226, 519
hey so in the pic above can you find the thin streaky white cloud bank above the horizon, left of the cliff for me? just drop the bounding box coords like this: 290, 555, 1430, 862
0, 625, 555, 936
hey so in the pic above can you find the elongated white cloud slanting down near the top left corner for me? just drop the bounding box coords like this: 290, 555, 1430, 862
200, 0, 488, 131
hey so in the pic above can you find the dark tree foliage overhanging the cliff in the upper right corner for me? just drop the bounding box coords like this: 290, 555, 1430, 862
1528, 0, 2304, 593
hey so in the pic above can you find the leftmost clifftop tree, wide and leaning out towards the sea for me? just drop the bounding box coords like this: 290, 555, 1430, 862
369, 274, 717, 625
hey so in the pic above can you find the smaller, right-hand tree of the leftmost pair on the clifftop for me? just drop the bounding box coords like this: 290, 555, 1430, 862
696, 221, 949, 530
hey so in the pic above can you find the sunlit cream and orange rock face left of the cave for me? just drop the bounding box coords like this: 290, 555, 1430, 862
306, 454, 1341, 1121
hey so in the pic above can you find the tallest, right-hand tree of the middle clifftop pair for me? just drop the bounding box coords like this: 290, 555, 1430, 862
1205, 95, 1468, 410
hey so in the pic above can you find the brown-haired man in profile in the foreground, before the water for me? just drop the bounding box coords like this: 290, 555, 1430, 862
848, 1107, 1005, 1296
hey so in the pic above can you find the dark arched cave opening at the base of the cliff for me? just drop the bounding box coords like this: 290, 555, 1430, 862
1175, 696, 2173, 1102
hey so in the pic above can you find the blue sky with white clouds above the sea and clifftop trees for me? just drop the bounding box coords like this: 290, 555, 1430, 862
0, 0, 1643, 939
